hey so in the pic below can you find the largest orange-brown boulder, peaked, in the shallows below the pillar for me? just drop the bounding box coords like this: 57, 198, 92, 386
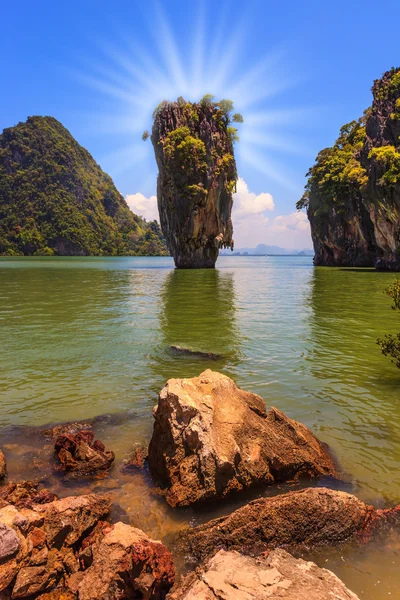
148, 370, 336, 506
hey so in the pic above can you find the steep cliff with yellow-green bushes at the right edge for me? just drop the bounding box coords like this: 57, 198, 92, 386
297, 68, 400, 270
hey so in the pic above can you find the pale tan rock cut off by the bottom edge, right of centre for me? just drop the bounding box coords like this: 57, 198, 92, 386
167, 550, 358, 600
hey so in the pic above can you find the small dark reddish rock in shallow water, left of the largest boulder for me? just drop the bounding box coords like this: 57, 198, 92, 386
54, 430, 115, 478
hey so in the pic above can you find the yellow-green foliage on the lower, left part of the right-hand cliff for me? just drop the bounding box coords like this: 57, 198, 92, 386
296, 119, 367, 210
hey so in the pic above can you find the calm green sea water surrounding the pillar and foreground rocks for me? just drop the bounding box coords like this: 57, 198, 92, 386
0, 257, 400, 600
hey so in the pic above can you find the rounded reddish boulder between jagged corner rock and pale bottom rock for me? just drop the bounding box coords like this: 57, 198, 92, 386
73, 523, 175, 600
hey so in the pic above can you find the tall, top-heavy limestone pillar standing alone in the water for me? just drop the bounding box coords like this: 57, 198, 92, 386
151, 100, 237, 268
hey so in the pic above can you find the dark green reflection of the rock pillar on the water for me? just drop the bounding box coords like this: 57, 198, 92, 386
153, 269, 240, 379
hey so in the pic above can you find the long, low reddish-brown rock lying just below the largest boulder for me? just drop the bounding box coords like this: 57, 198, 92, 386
180, 488, 400, 560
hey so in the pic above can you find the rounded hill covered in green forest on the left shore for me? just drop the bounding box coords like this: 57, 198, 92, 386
0, 117, 167, 256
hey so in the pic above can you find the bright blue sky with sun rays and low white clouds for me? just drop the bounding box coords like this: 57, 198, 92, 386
0, 0, 400, 249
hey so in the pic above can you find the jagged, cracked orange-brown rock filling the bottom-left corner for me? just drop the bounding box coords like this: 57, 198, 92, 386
0, 495, 111, 600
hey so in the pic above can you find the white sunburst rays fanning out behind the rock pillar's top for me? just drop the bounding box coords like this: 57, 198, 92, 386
74, 3, 312, 191
